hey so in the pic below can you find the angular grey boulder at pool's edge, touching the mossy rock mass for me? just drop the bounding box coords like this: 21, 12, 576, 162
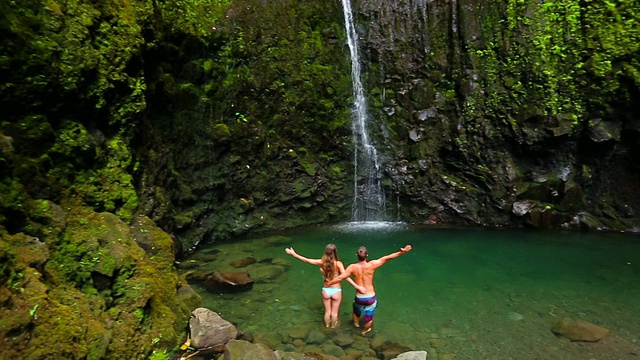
189, 308, 240, 352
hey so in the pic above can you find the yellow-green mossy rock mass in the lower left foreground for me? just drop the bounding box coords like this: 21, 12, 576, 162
0, 208, 197, 359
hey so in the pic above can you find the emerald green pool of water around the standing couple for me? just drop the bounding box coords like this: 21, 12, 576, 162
181, 226, 640, 359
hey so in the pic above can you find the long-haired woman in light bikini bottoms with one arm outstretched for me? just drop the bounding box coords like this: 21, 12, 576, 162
284, 244, 366, 328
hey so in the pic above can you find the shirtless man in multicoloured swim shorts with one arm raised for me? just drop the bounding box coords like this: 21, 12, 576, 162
325, 245, 411, 336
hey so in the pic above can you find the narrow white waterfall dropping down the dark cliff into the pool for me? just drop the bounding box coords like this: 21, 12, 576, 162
342, 0, 385, 222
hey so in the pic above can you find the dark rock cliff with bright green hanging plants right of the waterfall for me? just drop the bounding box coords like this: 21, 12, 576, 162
354, 0, 640, 229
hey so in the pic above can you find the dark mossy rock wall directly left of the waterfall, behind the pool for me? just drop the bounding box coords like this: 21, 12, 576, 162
135, 0, 351, 250
